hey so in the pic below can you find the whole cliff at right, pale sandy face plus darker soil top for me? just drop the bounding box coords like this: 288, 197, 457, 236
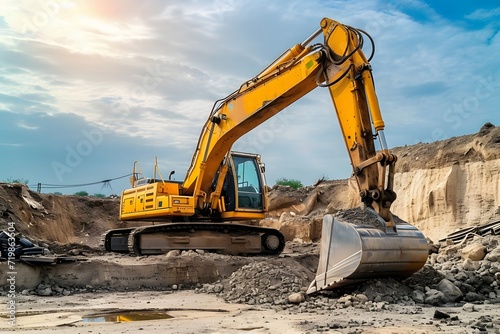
392, 125, 500, 241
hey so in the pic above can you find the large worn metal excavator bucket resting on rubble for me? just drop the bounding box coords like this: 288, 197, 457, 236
307, 209, 428, 294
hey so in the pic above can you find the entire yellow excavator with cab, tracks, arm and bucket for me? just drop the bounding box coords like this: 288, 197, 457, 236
104, 18, 428, 293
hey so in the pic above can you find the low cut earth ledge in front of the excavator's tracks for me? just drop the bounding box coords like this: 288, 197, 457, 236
4, 251, 249, 296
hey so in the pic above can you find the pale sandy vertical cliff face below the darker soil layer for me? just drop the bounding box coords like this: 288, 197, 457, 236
392, 159, 500, 241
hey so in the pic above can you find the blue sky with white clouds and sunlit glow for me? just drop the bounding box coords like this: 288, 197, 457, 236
0, 0, 500, 194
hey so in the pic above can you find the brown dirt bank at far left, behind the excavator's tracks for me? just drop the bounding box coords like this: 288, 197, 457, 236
0, 183, 123, 247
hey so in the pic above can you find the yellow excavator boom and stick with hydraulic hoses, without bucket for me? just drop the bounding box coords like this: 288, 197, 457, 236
182, 18, 396, 225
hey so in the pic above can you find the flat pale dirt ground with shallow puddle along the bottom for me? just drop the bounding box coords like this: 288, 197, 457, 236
0, 291, 500, 334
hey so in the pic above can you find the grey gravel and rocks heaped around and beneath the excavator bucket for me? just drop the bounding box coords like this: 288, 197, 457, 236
197, 235, 500, 312
